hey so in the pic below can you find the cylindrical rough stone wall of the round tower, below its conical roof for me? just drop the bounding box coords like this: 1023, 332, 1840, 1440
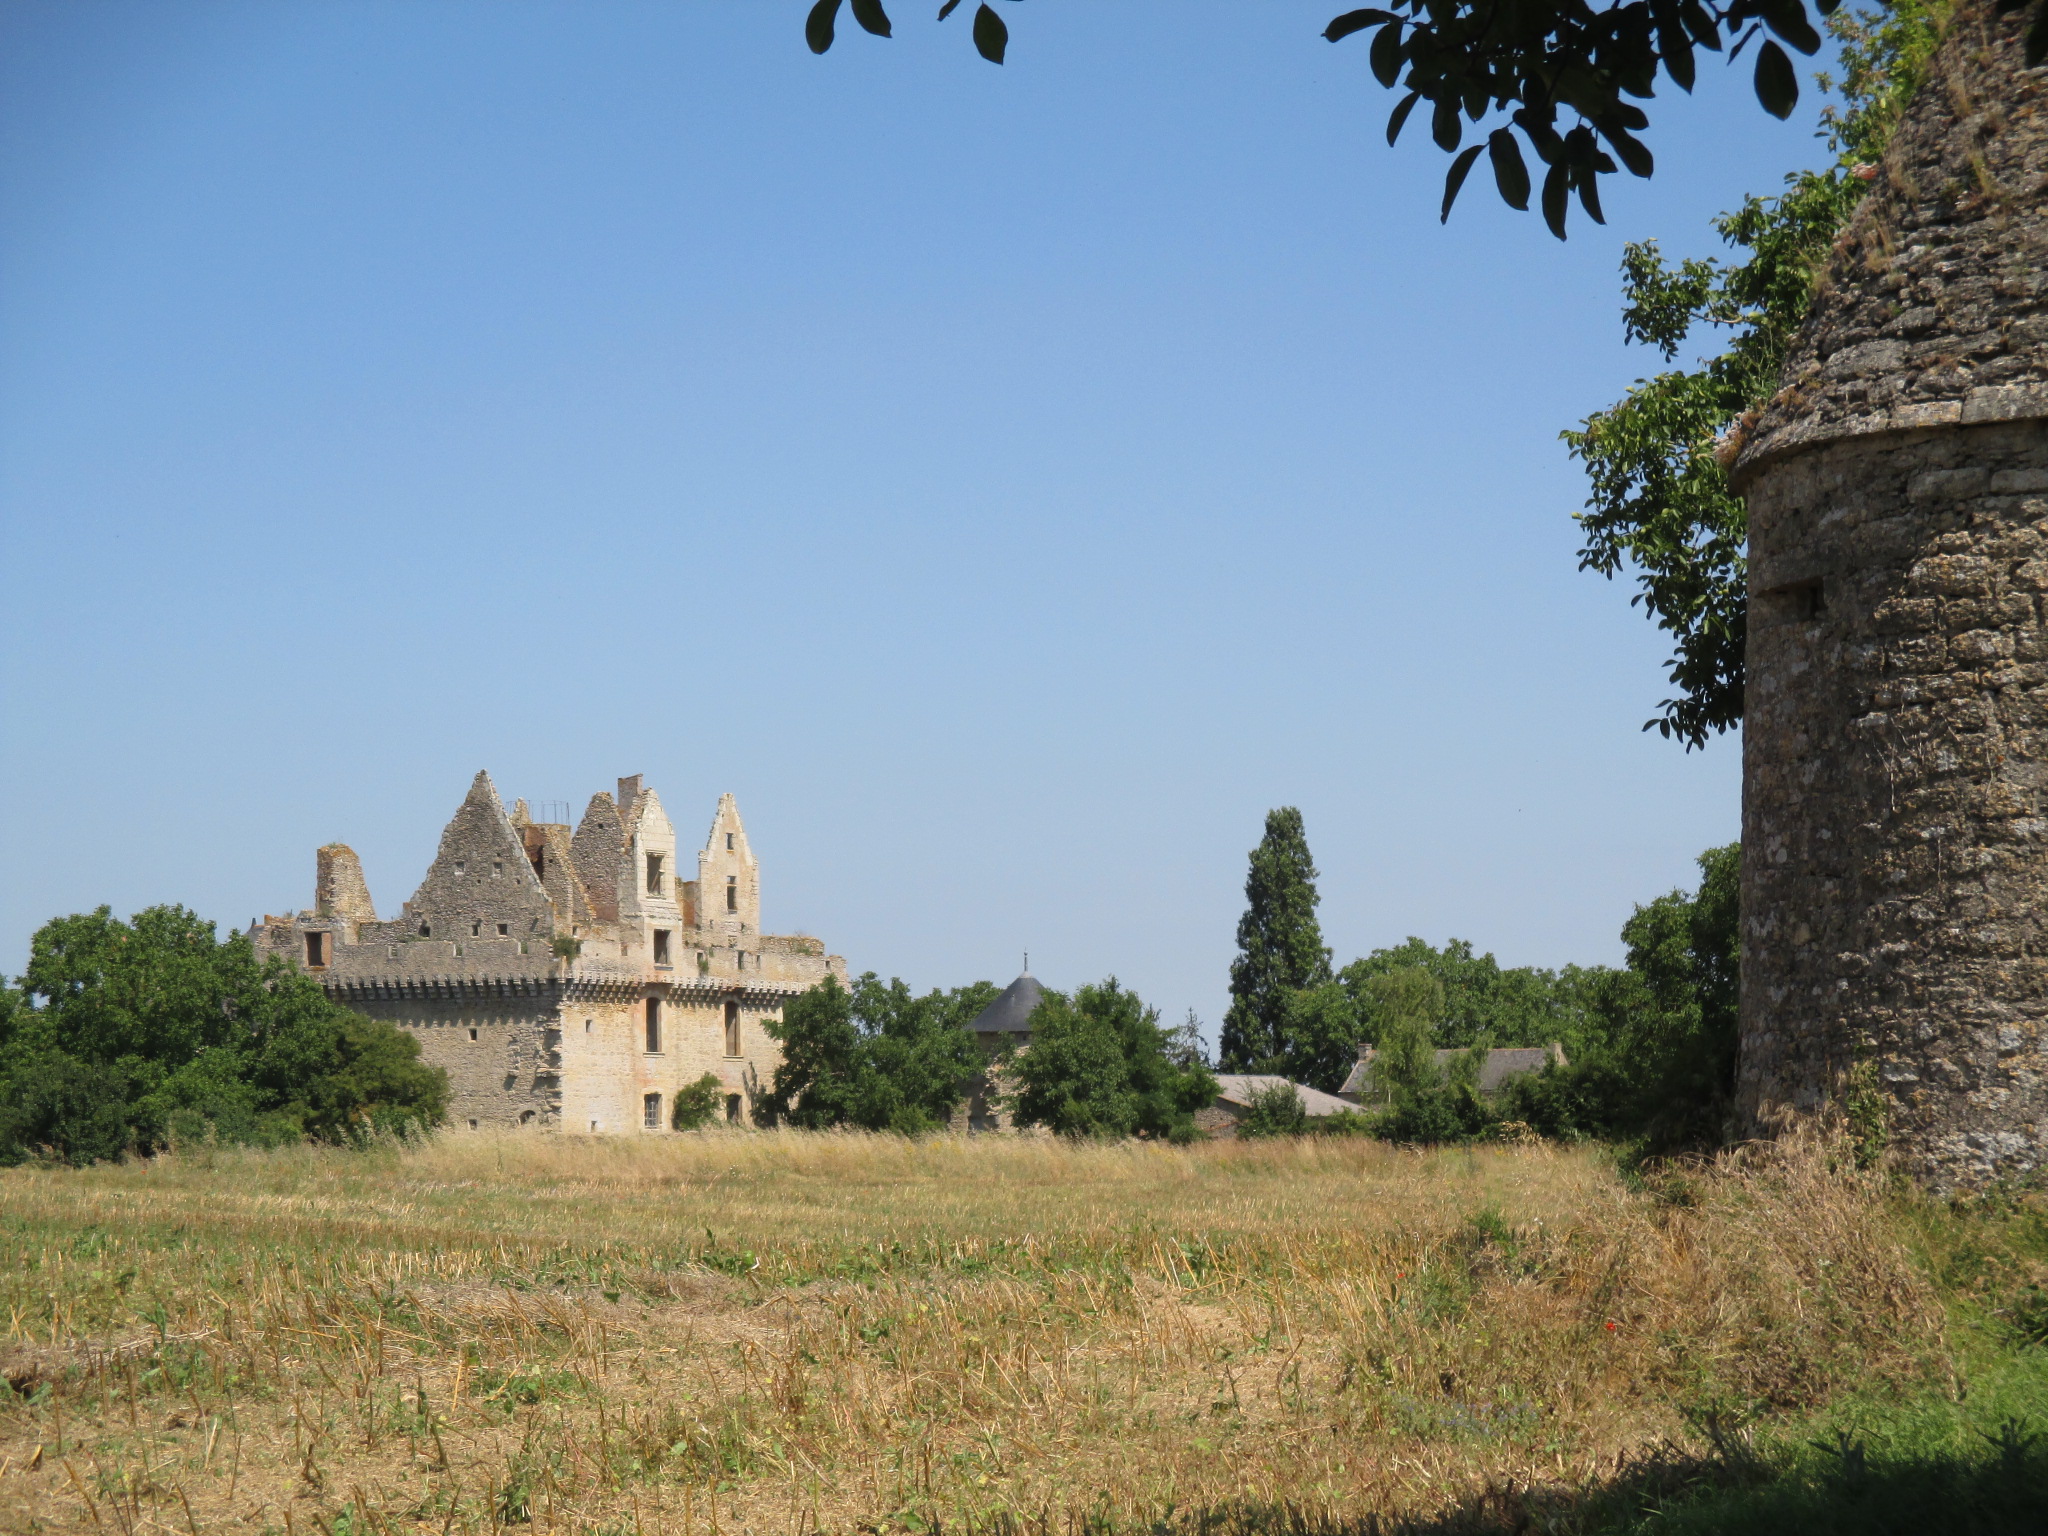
1739, 422, 2048, 1184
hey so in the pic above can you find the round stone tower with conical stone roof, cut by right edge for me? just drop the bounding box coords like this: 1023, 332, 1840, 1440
1733, 0, 2048, 1186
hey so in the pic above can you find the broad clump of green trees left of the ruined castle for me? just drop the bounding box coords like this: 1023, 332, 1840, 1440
0, 907, 449, 1163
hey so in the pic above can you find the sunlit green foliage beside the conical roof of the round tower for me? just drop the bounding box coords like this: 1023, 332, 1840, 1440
1563, 0, 1950, 748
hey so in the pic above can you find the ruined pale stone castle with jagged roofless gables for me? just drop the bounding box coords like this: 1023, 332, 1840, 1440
250, 774, 846, 1133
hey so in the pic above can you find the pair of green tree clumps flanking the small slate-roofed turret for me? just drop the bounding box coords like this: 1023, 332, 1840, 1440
756, 971, 1217, 1141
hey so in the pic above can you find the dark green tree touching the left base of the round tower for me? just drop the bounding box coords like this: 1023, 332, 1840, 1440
1501, 844, 1741, 1151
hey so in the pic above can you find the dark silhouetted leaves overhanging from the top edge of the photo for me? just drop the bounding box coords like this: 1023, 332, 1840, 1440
805, 0, 2048, 240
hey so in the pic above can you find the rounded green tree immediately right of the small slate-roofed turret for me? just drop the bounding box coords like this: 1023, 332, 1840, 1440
1010, 977, 1217, 1141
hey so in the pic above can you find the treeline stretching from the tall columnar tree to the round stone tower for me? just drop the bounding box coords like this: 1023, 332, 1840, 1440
1221, 807, 1741, 1149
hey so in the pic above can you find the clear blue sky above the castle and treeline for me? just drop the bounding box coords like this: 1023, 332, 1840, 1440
0, 0, 1817, 1030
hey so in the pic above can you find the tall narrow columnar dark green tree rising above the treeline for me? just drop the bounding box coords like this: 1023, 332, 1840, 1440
1219, 805, 1329, 1071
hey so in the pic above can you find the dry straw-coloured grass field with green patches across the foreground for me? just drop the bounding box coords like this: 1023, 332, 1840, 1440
0, 1133, 2048, 1536
